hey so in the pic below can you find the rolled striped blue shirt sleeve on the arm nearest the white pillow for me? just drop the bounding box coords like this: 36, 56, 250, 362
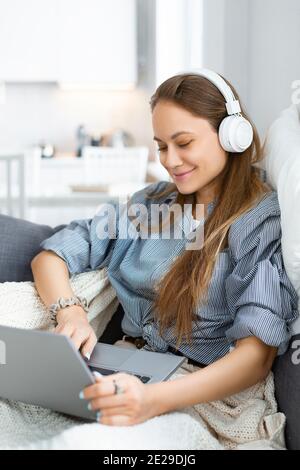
225, 197, 299, 355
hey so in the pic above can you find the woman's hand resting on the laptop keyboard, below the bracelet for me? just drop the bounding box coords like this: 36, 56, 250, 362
54, 305, 97, 360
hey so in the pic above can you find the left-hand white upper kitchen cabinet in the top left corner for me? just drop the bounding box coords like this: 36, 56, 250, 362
0, 0, 58, 82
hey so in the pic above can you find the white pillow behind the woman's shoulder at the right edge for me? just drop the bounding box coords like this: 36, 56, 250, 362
259, 105, 300, 334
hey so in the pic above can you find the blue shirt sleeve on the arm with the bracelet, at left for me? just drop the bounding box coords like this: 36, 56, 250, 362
41, 202, 119, 275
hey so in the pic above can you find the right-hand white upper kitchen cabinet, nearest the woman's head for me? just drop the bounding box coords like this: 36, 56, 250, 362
59, 0, 137, 86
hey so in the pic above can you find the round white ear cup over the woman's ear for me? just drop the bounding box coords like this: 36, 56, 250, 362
219, 115, 253, 153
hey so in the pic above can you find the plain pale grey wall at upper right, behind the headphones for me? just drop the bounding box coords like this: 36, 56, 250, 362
203, 0, 300, 138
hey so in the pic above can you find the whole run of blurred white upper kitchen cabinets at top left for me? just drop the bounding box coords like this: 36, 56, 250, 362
0, 0, 137, 88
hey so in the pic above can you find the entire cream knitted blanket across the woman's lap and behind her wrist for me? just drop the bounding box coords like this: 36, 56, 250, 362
0, 270, 285, 450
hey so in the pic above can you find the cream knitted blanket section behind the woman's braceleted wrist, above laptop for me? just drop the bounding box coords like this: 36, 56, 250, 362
0, 269, 119, 337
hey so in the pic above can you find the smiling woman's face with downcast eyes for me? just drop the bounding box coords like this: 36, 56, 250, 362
152, 100, 228, 204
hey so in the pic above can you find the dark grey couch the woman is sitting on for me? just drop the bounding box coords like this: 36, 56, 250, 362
0, 215, 300, 450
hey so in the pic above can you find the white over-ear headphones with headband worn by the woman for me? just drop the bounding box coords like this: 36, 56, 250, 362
175, 69, 253, 153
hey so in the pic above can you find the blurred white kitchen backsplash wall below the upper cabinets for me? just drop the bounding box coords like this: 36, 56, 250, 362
0, 84, 151, 151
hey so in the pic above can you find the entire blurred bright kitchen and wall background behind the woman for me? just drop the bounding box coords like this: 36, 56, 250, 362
0, 0, 300, 226
